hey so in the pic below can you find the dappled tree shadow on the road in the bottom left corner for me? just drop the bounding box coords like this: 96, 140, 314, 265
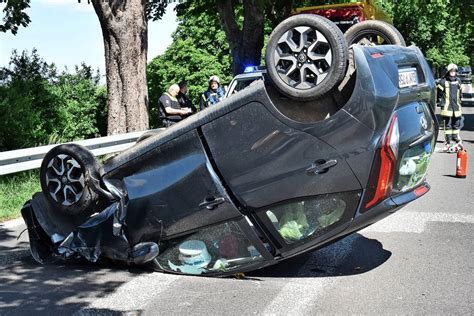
0, 229, 143, 315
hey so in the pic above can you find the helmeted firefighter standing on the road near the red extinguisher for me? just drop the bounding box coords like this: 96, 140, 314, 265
437, 64, 463, 152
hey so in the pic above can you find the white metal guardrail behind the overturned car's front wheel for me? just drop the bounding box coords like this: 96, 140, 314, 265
0, 132, 159, 175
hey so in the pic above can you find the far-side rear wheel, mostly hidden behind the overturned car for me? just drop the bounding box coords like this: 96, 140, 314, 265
344, 20, 406, 46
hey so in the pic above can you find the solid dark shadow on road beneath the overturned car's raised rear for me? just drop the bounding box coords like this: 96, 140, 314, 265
247, 233, 392, 278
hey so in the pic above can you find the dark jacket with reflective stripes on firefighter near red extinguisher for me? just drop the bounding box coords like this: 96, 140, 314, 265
437, 77, 462, 117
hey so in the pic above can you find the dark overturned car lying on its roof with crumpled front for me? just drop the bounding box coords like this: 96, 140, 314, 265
22, 15, 438, 276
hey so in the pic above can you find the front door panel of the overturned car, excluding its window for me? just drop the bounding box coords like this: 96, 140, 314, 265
106, 129, 242, 244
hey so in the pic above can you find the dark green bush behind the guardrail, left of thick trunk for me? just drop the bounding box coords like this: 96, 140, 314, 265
0, 50, 106, 150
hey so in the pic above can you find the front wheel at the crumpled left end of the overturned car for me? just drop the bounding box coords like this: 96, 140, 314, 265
40, 144, 100, 215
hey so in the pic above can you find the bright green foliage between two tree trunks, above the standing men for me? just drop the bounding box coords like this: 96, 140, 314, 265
147, 4, 232, 128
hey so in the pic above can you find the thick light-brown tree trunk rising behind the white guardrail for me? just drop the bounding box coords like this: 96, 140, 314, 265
92, 0, 148, 135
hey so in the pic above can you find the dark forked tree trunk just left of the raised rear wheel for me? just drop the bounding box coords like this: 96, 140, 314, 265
216, 0, 265, 75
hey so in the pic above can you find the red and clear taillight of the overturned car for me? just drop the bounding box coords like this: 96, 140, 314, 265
365, 114, 400, 209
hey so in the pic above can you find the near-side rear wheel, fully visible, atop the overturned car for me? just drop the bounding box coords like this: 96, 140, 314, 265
265, 14, 348, 101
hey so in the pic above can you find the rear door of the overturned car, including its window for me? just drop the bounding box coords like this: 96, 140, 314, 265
202, 102, 361, 253
